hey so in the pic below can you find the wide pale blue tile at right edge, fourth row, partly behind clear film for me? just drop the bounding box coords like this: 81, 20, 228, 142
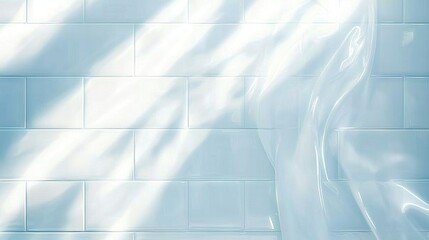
339, 130, 429, 180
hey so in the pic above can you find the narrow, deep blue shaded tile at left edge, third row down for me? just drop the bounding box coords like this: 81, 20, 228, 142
0, 78, 25, 127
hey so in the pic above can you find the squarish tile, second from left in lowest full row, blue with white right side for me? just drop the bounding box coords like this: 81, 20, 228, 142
27, 182, 84, 231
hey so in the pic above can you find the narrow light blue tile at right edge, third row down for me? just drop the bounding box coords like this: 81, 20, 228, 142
405, 78, 429, 128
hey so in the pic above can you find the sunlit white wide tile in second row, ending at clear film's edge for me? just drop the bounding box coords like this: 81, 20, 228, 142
136, 24, 272, 76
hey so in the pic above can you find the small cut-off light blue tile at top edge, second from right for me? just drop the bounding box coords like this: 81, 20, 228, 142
377, 0, 406, 22
